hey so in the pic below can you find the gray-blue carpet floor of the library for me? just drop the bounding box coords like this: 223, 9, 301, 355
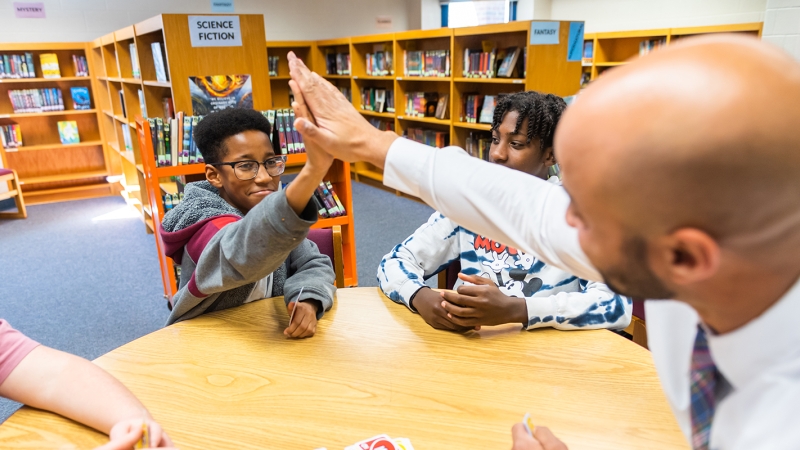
0, 182, 433, 423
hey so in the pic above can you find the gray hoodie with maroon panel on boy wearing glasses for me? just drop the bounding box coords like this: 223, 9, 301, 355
161, 181, 336, 325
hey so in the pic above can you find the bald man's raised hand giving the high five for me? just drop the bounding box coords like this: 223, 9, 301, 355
287, 52, 397, 168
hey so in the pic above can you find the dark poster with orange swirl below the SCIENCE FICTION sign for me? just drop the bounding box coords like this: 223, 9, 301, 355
189, 75, 253, 116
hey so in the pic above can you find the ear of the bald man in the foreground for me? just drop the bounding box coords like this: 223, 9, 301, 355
651, 228, 720, 286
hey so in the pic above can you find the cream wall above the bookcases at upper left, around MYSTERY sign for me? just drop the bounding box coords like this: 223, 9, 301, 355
0, 0, 409, 42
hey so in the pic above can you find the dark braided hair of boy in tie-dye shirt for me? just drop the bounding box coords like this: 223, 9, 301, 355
492, 91, 567, 150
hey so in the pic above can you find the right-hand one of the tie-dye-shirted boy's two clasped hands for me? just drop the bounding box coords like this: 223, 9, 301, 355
442, 273, 528, 327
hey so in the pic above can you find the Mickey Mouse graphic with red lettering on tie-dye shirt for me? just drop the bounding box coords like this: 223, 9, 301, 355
474, 236, 542, 298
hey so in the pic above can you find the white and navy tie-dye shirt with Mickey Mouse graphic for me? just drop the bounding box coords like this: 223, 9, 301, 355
378, 212, 633, 330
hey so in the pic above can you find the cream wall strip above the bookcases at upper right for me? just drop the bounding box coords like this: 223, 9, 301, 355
548, 0, 767, 33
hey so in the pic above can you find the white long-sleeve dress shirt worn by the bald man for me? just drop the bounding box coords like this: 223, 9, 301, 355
384, 139, 800, 450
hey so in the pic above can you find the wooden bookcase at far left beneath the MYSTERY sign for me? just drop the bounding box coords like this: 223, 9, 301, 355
0, 42, 116, 204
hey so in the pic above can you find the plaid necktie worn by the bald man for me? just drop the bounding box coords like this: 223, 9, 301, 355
691, 326, 717, 450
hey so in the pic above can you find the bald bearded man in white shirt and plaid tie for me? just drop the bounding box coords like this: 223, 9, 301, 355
290, 36, 800, 450
